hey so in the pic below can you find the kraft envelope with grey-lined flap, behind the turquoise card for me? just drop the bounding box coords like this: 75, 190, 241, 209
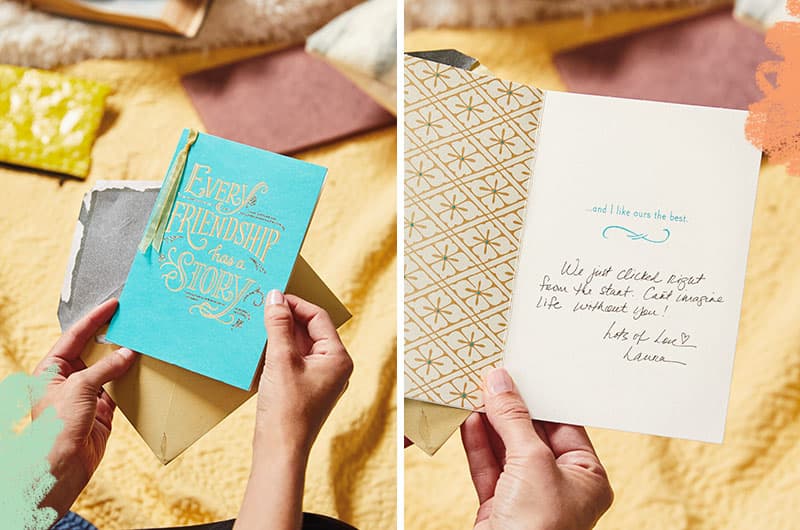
58, 181, 350, 464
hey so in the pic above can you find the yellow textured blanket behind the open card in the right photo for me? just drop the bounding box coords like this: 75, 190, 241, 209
405, 10, 800, 530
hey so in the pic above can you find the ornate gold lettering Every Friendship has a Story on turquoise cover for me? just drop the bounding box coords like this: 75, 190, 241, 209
159, 163, 284, 327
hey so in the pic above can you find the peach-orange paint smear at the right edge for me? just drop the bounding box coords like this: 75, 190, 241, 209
745, 0, 800, 176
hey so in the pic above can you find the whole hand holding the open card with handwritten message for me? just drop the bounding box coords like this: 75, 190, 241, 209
461, 368, 614, 530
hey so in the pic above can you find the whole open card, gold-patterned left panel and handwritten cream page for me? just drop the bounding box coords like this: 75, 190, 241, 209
404, 53, 760, 442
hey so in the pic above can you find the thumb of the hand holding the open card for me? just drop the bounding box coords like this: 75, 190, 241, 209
483, 368, 547, 454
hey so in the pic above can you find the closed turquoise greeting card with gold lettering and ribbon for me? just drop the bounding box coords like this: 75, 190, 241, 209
107, 129, 327, 389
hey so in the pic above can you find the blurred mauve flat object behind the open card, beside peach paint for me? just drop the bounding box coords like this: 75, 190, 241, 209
554, 7, 776, 110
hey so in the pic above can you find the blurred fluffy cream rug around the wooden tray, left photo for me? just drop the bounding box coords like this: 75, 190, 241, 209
0, 0, 359, 68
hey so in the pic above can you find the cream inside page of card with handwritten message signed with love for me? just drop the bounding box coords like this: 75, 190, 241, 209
504, 92, 760, 442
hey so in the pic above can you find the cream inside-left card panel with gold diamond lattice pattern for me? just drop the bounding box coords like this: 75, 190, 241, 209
404, 56, 544, 409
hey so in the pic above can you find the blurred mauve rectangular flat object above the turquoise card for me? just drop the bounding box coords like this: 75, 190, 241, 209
182, 44, 395, 154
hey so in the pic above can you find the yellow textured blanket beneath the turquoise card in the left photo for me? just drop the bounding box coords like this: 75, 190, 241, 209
0, 44, 396, 529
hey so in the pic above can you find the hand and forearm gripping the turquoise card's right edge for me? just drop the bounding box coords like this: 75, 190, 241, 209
235, 291, 353, 530
